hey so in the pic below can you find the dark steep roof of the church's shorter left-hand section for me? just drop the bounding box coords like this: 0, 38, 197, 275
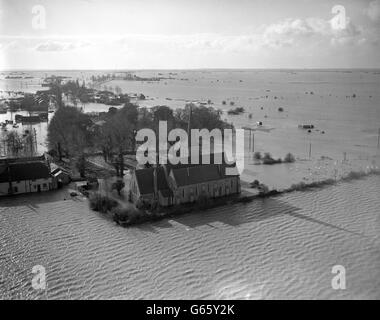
135, 167, 169, 194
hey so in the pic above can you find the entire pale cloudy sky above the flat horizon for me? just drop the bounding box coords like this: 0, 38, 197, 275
0, 0, 380, 69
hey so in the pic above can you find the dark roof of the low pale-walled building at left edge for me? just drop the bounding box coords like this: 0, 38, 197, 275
0, 161, 50, 182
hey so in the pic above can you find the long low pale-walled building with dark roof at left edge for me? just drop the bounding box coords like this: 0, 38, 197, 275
0, 160, 54, 196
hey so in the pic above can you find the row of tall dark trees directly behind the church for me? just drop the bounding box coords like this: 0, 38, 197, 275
48, 102, 232, 177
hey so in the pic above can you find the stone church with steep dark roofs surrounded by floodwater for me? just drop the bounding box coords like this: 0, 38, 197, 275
130, 154, 240, 207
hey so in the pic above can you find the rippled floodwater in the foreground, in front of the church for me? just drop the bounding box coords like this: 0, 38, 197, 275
0, 176, 380, 299
